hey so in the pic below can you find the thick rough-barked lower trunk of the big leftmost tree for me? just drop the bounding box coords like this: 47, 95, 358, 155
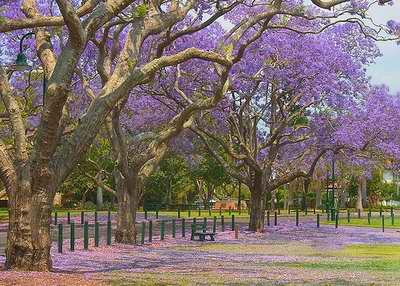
6, 183, 53, 271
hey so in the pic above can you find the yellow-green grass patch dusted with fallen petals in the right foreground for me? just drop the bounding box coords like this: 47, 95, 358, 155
105, 242, 400, 286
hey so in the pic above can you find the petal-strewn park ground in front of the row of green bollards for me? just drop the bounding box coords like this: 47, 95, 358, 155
0, 217, 400, 285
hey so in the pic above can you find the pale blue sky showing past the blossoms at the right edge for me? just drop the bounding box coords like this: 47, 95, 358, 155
368, 0, 400, 92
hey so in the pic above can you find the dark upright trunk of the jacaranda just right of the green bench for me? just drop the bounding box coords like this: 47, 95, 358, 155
249, 174, 265, 232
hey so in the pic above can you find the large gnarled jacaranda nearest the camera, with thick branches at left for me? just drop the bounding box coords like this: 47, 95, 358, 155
0, 0, 396, 271
